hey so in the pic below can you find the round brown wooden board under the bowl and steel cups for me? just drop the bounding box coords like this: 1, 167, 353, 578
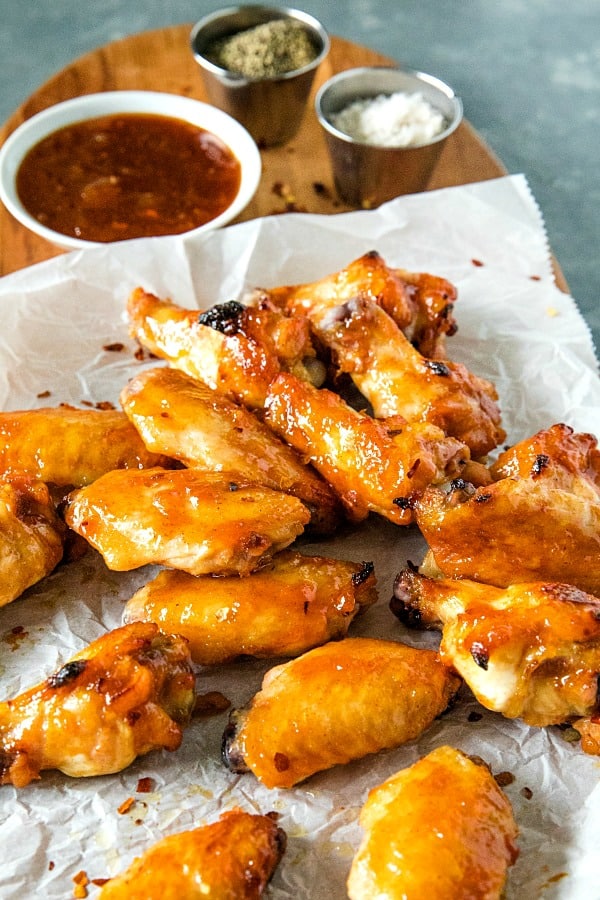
0, 25, 506, 275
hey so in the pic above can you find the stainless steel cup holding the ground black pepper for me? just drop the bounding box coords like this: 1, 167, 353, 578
190, 6, 330, 147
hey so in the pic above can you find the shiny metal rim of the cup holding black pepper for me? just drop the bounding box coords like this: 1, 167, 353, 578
190, 3, 331, 84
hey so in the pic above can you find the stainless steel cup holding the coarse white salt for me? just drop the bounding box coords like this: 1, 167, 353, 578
315, 66, 463, 208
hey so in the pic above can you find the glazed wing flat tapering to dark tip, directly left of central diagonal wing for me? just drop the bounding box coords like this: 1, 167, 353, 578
121, 367, 340, 534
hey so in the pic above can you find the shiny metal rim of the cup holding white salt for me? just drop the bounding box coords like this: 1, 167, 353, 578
314, 64, 464, 151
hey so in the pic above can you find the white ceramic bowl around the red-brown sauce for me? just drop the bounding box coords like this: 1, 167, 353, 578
0, 91, 262, 250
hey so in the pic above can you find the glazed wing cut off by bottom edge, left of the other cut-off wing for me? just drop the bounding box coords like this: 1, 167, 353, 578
98, 809, 287, 900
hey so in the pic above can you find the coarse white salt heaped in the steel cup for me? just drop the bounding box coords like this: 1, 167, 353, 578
330, 91, 446, 147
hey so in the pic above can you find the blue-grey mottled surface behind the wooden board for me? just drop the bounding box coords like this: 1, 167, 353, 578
0, 0, 600, 349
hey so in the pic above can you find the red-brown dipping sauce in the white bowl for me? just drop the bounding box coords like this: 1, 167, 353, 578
17, 113, 241, 242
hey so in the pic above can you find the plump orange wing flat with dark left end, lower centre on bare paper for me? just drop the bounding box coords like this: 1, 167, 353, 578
223, 638, 460, 788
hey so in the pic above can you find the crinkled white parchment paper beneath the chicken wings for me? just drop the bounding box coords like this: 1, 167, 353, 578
0, 176, 600, 900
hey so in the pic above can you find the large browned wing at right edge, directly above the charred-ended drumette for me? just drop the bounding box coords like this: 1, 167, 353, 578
415, 425, 600, 594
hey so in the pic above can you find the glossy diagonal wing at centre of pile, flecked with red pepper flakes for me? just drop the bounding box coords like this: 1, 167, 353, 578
265, 374, 469, 525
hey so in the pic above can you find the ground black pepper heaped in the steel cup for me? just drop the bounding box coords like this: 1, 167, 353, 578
206, 19, 317, 78
